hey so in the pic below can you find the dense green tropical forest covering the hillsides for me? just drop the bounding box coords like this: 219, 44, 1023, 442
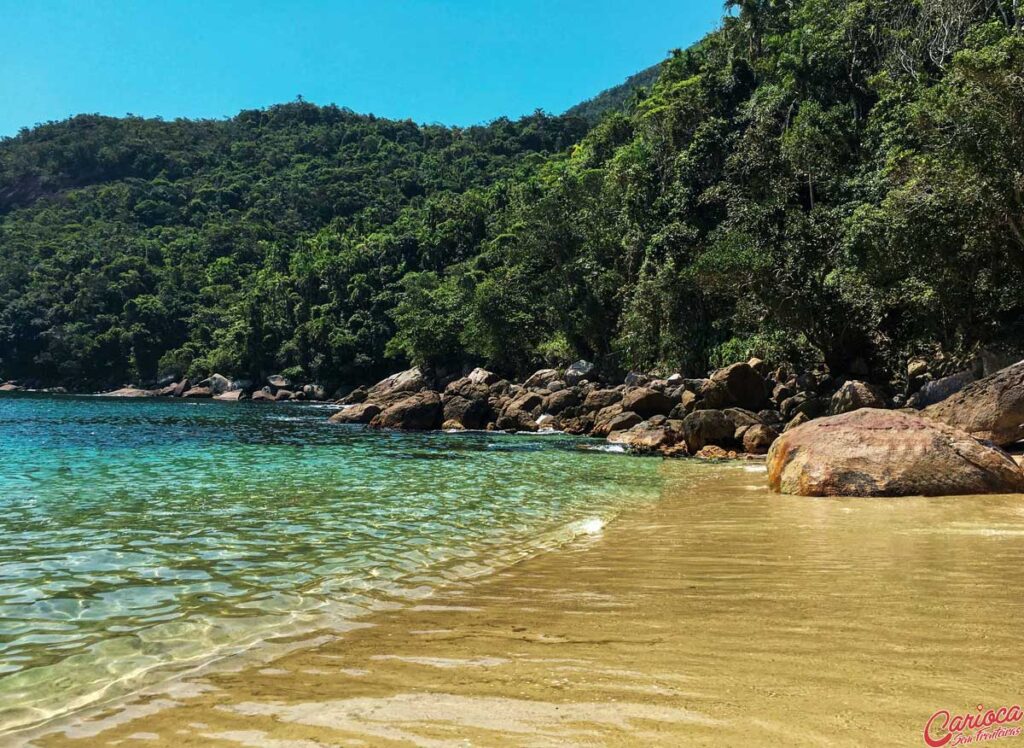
0, 0, 1024, 387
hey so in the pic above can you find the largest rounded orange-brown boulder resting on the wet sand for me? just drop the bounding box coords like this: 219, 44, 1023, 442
768, 408, 1024, 496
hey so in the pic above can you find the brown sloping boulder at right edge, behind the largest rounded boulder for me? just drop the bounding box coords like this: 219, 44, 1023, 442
922, 361, 1024, 447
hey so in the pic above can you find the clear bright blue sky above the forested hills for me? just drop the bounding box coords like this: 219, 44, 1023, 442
0, 0, 723, 136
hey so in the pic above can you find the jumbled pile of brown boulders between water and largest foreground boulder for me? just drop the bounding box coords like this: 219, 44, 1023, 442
332, 359, 885, 456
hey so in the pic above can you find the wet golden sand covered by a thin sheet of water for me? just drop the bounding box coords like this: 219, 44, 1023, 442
22, 461, 1024, 748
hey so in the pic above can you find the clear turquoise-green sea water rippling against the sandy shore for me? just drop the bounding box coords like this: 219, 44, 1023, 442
0, 394, 658, 732
